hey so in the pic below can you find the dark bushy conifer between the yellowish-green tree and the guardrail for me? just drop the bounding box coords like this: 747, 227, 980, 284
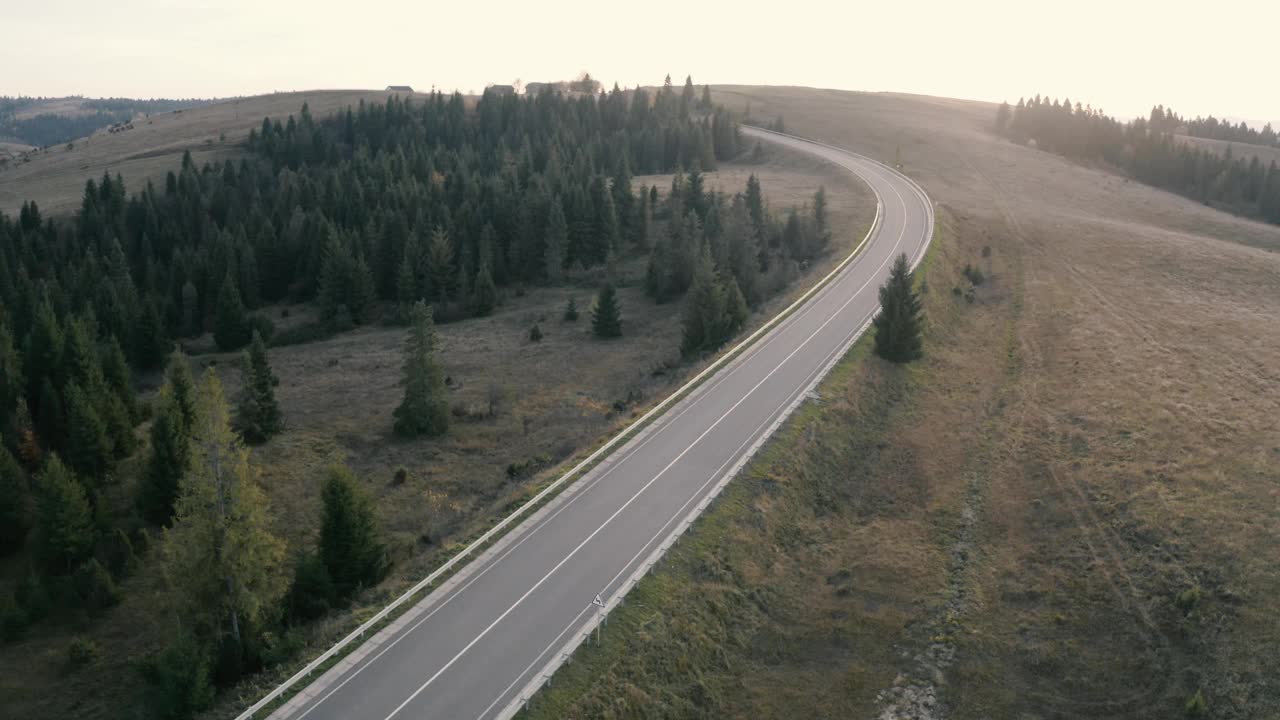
319, 464, 390, 597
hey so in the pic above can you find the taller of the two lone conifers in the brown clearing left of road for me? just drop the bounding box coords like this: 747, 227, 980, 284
396, 301, 449, 437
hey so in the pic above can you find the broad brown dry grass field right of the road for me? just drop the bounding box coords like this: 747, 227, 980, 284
522, 87, 1280, 719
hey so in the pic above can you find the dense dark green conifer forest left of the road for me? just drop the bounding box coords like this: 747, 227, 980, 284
0, 78, 831, 717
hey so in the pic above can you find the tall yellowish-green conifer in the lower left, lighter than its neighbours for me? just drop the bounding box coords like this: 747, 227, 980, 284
163, 368, 284, 647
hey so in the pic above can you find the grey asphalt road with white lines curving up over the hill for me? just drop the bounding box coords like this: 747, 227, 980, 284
271, 128, 933, 720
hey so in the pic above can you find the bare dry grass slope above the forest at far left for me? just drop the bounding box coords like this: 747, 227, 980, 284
0, 90, 432, 215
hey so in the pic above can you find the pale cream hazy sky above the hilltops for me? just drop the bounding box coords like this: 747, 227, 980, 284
0, 0, 1280, 124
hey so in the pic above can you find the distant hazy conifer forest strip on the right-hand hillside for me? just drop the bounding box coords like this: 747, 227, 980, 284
996, 96, 1280, 223
